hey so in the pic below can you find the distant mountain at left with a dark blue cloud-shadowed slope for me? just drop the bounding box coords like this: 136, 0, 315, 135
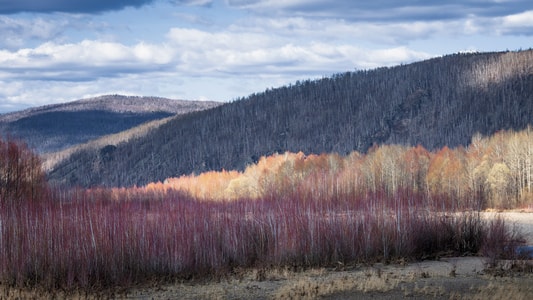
0, 95, 219, 154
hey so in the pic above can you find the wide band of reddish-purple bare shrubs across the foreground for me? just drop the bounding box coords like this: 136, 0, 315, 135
0, 190, 516, 290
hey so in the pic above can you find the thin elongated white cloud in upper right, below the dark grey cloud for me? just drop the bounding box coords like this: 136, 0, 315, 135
232, 17, 489, 47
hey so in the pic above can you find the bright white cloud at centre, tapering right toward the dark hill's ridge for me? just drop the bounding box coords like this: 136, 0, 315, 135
168, 28, 429, 76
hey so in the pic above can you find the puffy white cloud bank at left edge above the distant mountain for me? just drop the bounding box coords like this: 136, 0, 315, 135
0, 40, 173, 81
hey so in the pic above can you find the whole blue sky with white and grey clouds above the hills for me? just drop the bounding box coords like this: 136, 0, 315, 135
0, 0, 533, 113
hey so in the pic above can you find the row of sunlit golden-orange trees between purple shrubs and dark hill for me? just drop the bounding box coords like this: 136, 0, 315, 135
141, 127, 533, 209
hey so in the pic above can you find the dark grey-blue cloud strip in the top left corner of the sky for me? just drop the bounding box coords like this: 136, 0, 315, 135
0, 0, 156, 14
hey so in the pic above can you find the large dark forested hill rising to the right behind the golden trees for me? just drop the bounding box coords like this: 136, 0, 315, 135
49, 50, 533, 186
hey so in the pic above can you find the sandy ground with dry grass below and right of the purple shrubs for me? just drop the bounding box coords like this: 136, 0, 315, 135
0, 212, 533, 300
